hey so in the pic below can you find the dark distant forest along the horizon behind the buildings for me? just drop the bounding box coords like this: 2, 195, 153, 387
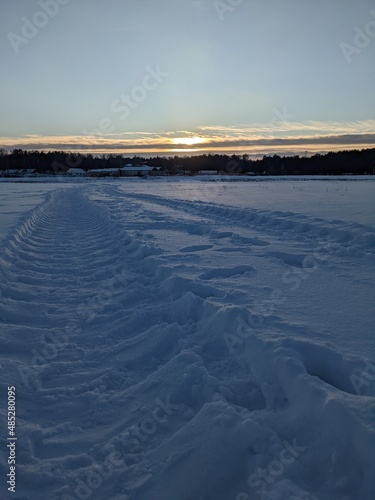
0, 148, 375, 175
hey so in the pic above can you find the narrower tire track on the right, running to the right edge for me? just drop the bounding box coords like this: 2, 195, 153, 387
115, 189, 375, 258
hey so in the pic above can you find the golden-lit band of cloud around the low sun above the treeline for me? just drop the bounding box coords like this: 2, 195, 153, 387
0, 120, 375, 154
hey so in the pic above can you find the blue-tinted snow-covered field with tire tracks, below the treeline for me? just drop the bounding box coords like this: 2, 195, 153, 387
0, 177, 375, 500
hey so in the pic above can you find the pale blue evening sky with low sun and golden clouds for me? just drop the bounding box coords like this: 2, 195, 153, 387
0, 0, 375, 156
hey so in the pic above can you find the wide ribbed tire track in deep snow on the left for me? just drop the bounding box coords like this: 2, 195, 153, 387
0, 188, 262, 499
